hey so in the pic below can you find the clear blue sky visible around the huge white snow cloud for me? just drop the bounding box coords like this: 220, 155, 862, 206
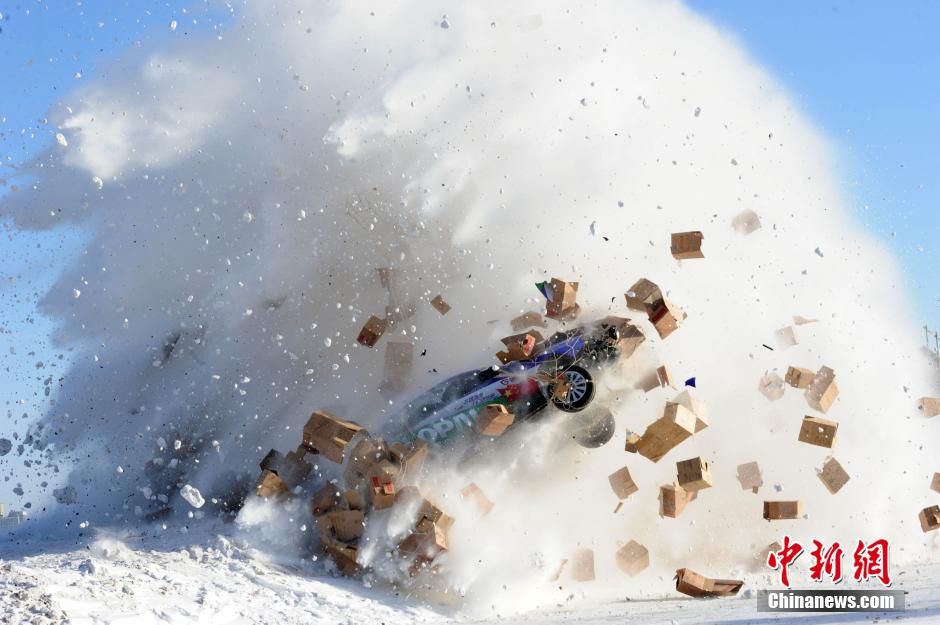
0, 0, 940, 501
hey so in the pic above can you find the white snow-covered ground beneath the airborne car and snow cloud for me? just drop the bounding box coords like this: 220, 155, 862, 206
0, 522, 940, 625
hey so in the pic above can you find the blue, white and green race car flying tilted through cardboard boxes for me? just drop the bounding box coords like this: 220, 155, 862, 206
390, 317, 644, 447
